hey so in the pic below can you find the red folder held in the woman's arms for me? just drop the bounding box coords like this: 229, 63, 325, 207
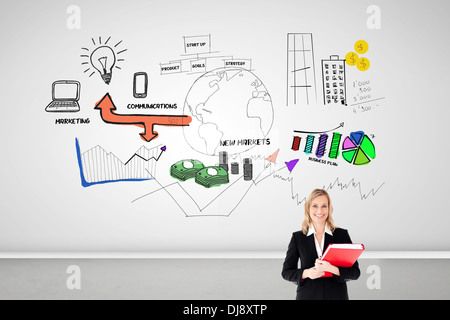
320, 243, 364, 278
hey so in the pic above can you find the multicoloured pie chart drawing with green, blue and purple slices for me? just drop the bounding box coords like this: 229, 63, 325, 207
342, 131, 376, 166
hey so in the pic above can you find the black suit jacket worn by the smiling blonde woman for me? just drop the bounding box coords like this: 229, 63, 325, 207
281, 228, 361, 300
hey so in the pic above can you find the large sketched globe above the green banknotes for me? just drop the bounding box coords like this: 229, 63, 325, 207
183, 68, 273, 155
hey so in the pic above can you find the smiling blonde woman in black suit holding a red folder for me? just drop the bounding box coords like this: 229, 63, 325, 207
281, 189, 361, 300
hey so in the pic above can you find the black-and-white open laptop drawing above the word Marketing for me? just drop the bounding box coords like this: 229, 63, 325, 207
45, 80, 81, 112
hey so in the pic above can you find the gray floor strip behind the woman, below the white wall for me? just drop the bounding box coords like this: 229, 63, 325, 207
0, 259, 450, 300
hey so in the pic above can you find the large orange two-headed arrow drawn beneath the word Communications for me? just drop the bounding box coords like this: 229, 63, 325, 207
94, 93, 192, 142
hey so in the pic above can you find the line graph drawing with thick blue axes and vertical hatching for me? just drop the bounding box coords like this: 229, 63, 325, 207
75, 138, 166, 188
